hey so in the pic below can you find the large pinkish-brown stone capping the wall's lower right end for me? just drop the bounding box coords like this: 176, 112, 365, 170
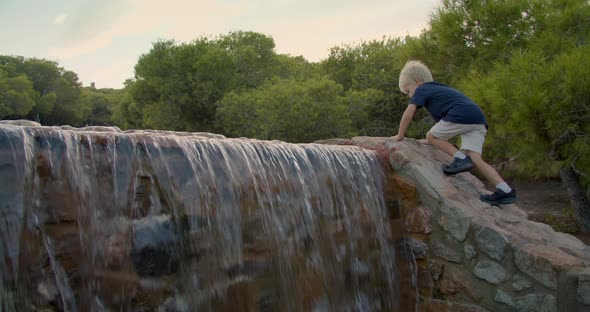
514, 244, 584, 290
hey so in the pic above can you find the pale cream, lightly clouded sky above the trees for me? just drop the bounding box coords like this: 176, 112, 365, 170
0, 0, 441, 89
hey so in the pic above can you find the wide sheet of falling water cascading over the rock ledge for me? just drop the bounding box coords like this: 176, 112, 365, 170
0, 125, 416, 311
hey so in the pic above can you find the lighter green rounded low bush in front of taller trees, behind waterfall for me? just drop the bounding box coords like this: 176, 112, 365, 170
218, 78, 351, 142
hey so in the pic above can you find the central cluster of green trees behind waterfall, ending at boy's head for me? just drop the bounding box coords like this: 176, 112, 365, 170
117, 31, 420, 142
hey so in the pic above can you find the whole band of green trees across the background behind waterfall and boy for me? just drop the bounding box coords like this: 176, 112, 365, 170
0, 0, 590, 223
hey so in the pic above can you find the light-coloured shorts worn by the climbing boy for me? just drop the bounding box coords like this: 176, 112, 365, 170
430, 120, 488, 154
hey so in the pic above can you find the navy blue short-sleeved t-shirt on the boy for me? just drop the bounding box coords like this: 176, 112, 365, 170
410, 81, 486, 125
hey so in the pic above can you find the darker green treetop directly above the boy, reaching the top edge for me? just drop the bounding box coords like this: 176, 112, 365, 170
427, 0, 538, 83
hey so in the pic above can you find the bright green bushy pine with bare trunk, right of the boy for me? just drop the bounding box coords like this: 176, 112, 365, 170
463, 45, 590, 232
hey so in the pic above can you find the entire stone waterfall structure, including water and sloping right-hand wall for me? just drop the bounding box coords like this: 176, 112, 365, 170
0, 123, 590, 311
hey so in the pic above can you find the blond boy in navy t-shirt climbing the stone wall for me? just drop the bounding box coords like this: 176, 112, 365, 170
392, 61, 516, 205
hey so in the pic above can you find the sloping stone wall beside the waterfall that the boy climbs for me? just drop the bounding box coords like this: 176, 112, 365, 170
330, 137, 590, 312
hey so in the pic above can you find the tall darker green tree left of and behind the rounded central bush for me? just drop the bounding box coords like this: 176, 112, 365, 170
127, 32, 288, 131
